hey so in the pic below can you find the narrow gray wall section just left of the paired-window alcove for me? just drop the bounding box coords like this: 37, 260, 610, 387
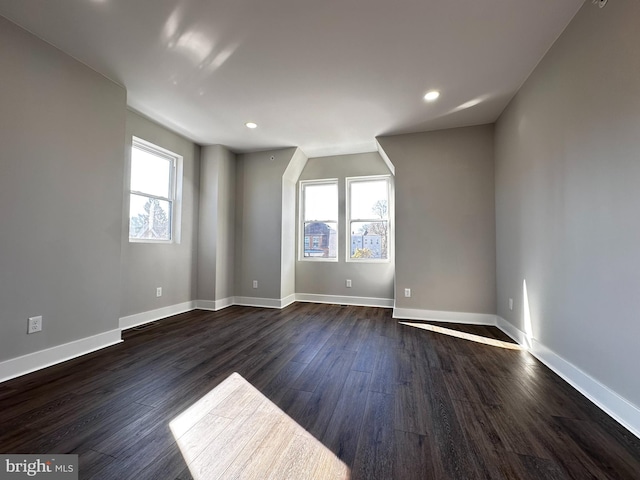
235, 148, 297, 300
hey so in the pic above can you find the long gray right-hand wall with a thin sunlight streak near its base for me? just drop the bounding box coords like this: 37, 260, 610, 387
496, 0, 640, 406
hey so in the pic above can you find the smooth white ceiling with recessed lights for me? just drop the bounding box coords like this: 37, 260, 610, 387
0, 0, 583, 156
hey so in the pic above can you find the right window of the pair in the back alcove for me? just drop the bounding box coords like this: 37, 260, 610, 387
347, 177, 390, 261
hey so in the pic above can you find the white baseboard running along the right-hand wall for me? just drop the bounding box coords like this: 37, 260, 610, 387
497, 317, 640, 438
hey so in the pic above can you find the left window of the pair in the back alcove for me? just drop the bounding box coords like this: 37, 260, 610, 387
300, 180, 338, 261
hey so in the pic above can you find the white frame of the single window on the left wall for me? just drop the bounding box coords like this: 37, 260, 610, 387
127, 135, 182, 244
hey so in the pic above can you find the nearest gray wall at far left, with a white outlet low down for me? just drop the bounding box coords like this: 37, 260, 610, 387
0, 17, 126, 360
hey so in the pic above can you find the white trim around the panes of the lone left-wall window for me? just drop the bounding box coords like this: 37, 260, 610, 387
127, 135, 183, 244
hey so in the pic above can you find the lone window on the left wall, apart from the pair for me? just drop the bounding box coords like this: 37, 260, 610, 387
129, 137, 182, 242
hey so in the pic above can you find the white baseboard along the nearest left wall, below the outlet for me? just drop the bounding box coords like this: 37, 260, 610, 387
0, 329, 122, 382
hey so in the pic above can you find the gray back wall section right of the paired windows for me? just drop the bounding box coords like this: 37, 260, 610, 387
378, 125, 496, 314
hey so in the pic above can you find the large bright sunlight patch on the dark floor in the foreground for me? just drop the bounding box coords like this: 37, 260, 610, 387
169, 373, 350, 480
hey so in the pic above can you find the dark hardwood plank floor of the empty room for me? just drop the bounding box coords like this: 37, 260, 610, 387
0, 303, 640, 480
